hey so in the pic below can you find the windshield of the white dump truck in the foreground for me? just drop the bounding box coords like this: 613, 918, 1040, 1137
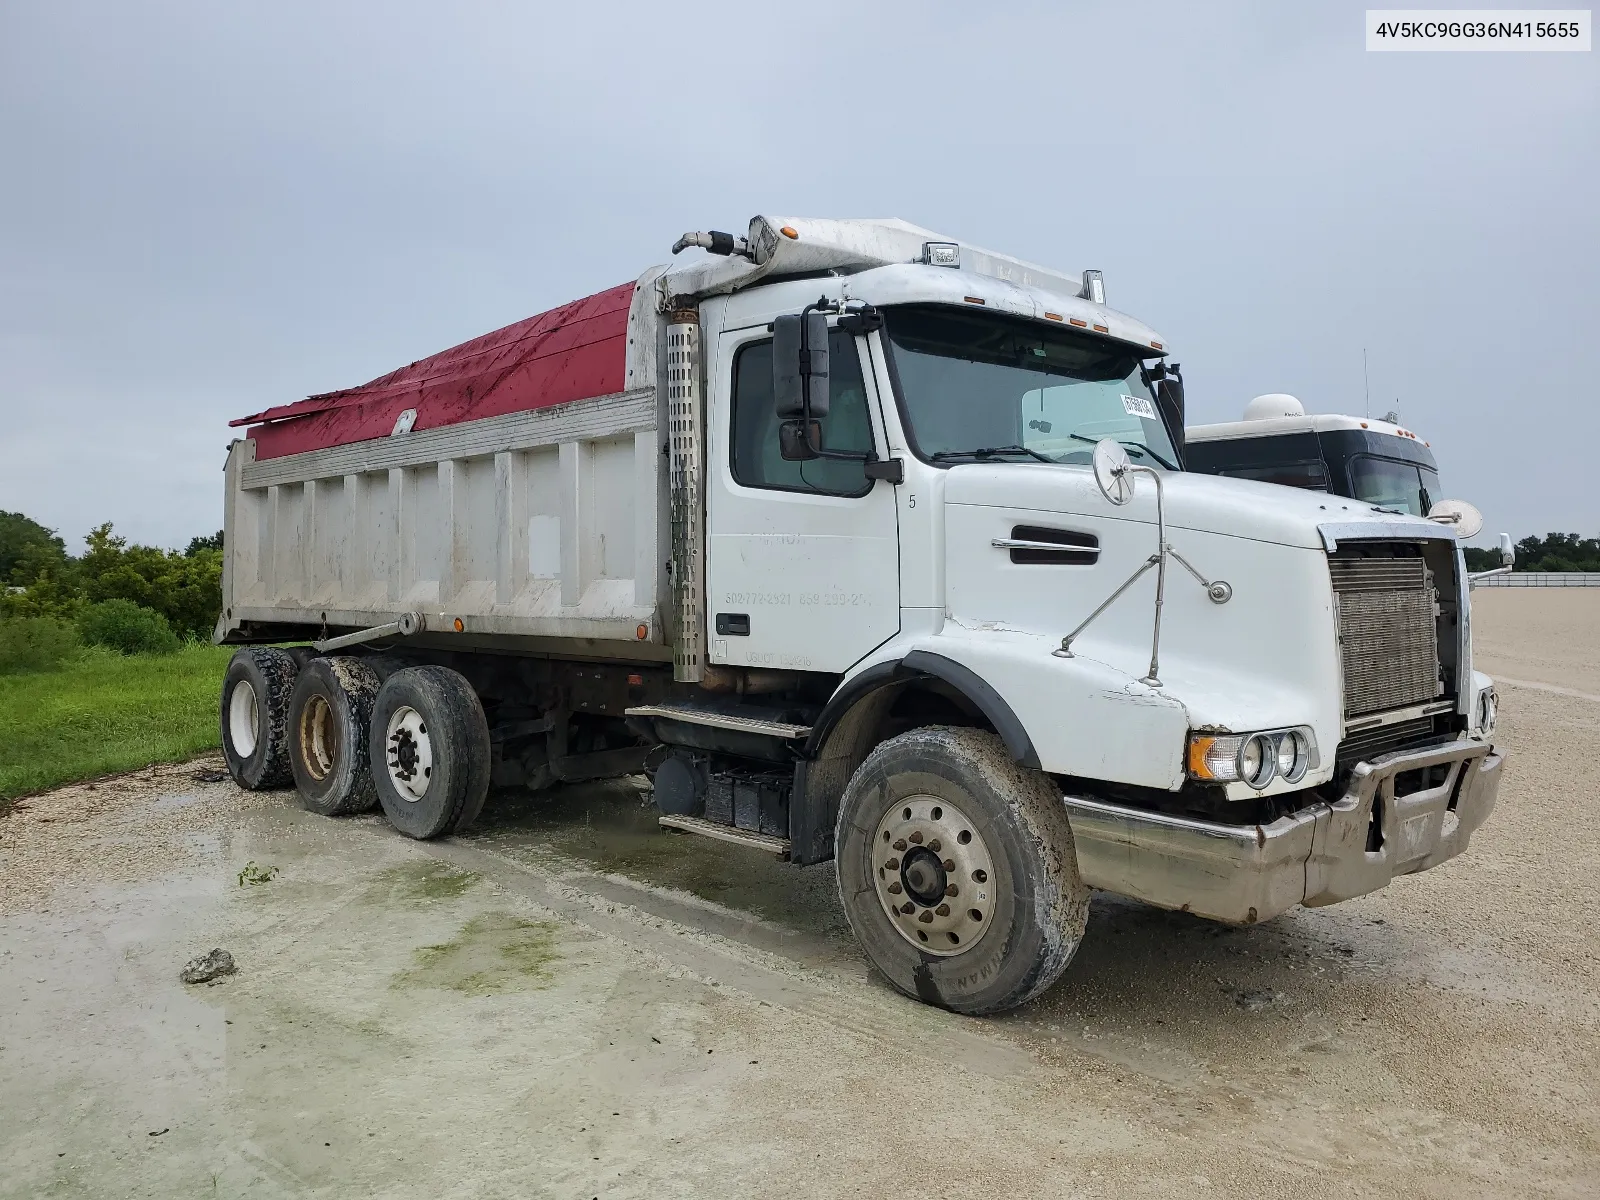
885, 304, 1178, 467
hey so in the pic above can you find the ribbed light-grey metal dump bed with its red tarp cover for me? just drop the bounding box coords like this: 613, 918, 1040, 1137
218, 270, 669, 658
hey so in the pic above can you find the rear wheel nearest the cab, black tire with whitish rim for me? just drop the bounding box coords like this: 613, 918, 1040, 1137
368, 667, 490, 838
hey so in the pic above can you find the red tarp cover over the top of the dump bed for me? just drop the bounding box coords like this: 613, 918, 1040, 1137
230, 283, 634, 462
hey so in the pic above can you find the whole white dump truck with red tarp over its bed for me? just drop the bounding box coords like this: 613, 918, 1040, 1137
216, 216, 1501, 1013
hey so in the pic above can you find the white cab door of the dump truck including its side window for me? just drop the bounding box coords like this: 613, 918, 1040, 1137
706, 325, 899, 672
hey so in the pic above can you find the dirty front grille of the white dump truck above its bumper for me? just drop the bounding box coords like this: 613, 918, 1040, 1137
1328, 546, 1443, 717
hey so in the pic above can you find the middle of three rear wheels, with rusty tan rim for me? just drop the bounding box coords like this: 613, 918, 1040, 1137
290, 658, 378, 816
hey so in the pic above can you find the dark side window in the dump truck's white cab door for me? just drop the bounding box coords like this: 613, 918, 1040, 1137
731, 330, 872, 496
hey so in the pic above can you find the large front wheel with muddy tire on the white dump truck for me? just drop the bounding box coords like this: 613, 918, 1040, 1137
834, 726, 1088, 1016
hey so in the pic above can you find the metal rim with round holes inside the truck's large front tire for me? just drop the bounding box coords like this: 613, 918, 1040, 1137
870, 795, 995, 958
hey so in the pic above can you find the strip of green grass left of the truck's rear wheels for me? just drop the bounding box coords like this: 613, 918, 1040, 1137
0, 645, 232, 813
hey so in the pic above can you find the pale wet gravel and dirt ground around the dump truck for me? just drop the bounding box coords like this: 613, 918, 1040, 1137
0, 590, 1600, 1197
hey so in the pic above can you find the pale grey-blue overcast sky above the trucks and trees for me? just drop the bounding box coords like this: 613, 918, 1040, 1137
0, 0, 1600, 547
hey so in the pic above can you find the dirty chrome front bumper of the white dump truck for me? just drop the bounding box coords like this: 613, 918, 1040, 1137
1066, 741, 1504, 925
